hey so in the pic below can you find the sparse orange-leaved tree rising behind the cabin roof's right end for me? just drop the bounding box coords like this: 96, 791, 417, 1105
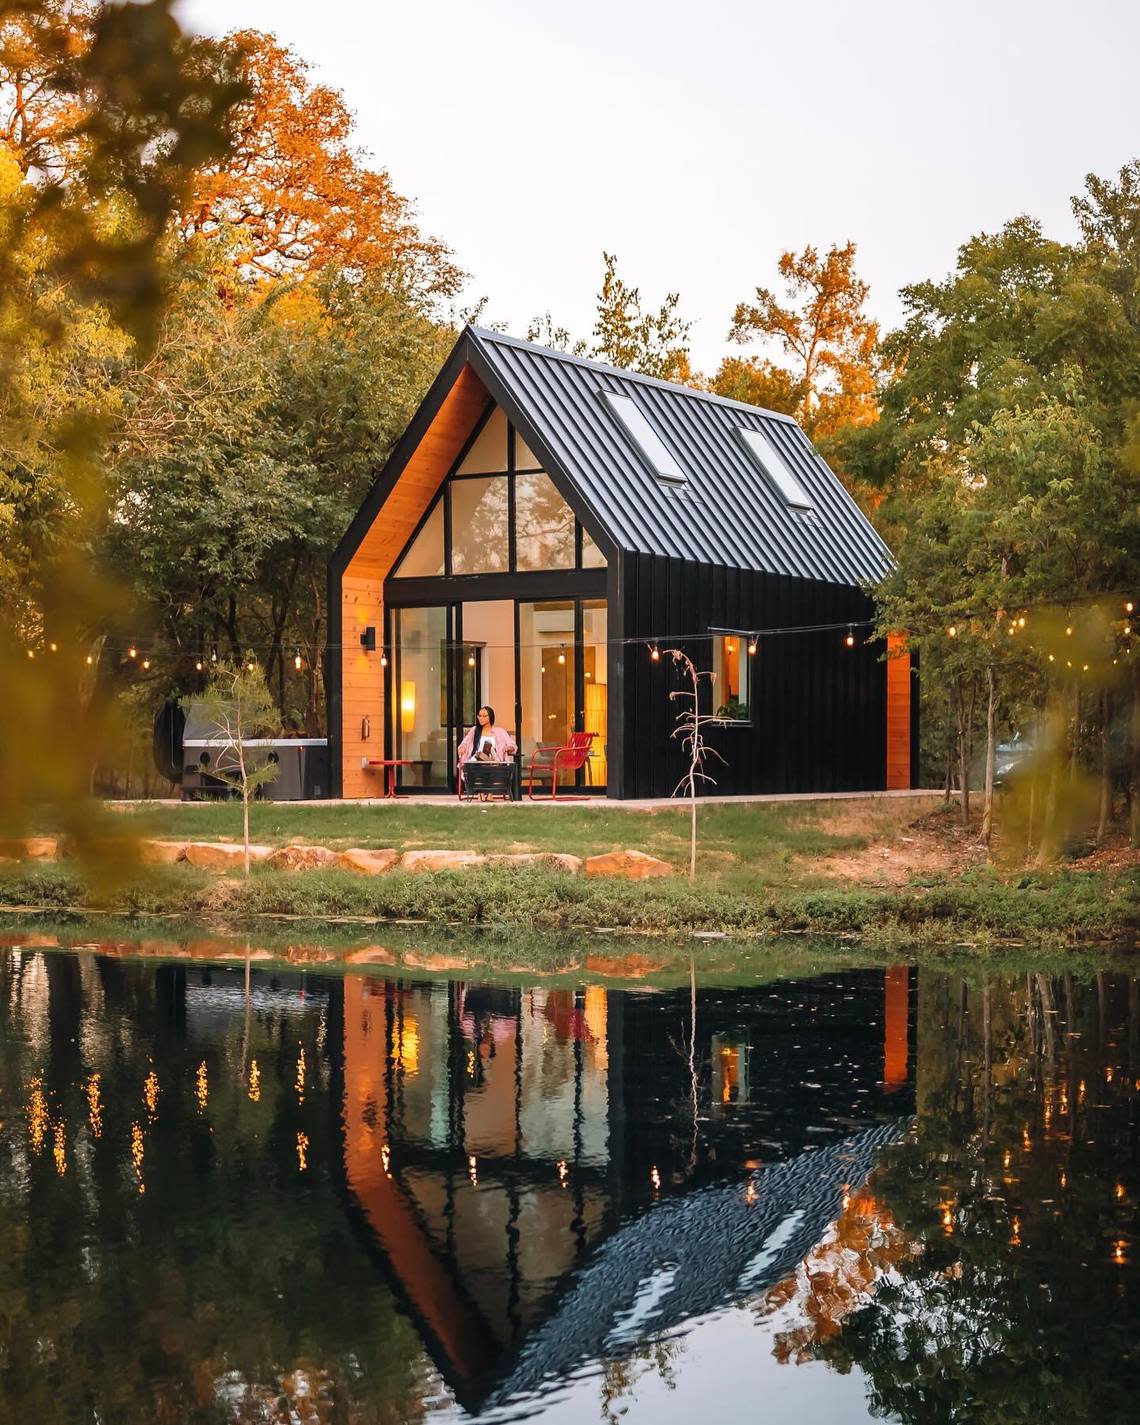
729, 242, 879, 436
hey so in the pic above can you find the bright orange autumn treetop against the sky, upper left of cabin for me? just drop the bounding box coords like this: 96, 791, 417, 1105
178, 30, 462, 298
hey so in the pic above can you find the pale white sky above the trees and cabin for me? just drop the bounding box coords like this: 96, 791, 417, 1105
181, 0, 1140, 372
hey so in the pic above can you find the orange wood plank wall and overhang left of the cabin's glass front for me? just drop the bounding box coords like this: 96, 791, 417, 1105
333, 366, 490, 797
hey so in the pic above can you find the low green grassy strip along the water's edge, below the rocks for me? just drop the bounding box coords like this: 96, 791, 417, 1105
0, 864, 1140, 945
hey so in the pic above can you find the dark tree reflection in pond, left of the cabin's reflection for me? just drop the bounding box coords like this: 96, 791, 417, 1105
0, 952, 422, 1425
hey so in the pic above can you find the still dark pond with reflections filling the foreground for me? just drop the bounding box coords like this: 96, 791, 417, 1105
0, 933, 1140, 1425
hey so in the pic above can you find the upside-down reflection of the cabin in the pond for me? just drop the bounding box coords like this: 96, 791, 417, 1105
333, 969, 913, 1406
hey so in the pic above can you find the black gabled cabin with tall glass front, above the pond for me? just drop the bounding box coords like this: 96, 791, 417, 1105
328, 328, 918, 797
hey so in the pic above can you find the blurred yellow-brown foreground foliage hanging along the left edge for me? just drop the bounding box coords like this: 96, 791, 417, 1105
0, 0, 237, 831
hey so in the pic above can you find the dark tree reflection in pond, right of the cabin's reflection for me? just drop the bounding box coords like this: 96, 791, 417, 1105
809, 973, 1140, 1425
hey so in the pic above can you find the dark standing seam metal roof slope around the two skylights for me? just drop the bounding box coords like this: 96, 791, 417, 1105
466, 326, 892, 584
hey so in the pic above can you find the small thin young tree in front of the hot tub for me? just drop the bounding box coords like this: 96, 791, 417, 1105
192, 661, 281, 876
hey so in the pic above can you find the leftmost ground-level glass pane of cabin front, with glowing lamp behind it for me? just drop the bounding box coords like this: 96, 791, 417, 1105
390, 608, 450, 787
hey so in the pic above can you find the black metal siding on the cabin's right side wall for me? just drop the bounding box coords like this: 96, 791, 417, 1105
610, 554, 886, 798
